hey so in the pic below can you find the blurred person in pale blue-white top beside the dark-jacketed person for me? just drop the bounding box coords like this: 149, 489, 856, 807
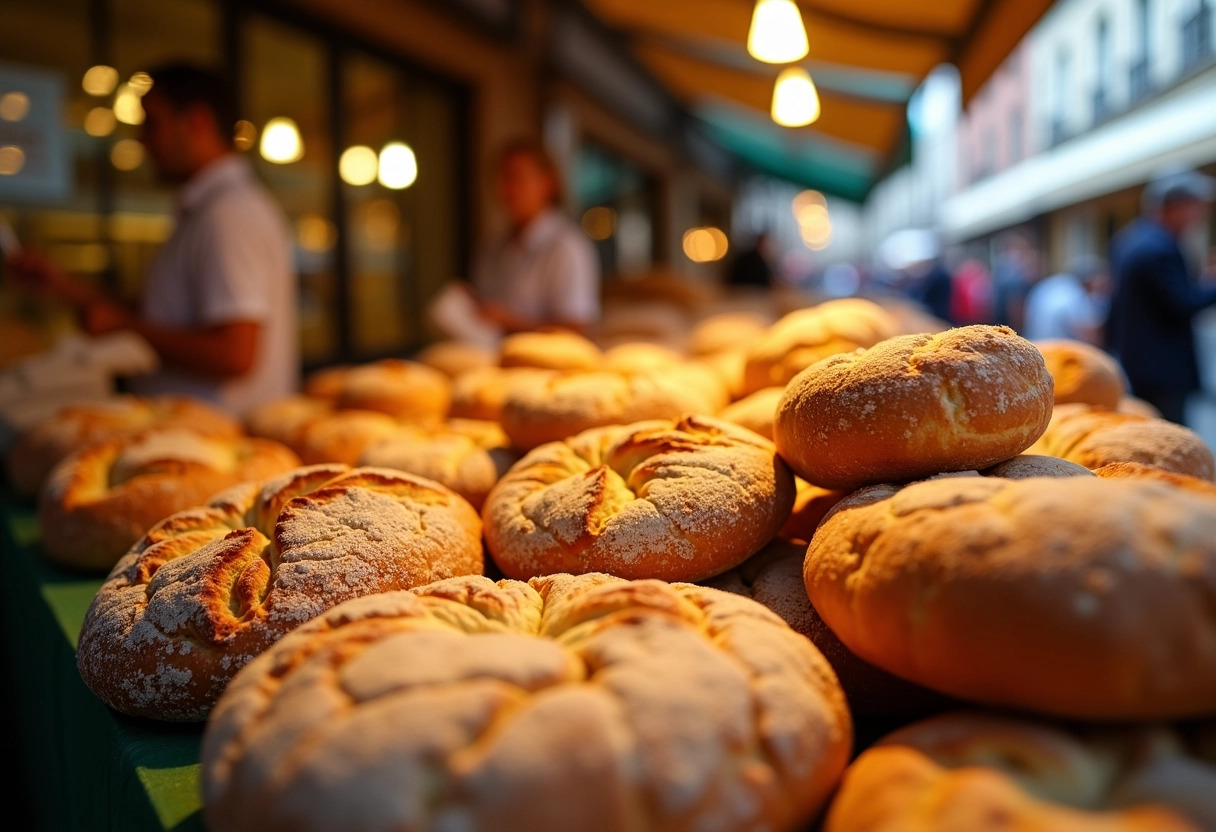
1019, 255, 1110, 347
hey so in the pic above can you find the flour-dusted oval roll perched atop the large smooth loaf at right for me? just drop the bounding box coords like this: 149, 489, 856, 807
773, 325, 1052, 490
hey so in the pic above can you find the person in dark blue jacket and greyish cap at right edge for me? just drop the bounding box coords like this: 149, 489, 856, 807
1105, 169, 1216, 425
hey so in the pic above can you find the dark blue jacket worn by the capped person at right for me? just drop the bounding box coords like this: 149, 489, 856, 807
1107, 219, 1216, 394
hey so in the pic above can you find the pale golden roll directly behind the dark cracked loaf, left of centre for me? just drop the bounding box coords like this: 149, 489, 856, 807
359, 418, 519, 510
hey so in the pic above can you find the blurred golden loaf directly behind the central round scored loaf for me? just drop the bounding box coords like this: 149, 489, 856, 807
500, 364, 728, 450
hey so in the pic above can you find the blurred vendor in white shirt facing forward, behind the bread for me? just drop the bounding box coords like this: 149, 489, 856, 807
471, 140, 601, 332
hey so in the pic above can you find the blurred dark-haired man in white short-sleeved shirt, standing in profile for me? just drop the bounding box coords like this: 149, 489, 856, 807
9, 63, 299, 416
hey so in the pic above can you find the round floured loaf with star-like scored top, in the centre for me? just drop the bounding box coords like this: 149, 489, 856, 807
482, 416, 794, 580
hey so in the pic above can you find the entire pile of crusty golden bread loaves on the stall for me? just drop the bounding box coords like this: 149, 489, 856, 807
10, 299, 1216, 832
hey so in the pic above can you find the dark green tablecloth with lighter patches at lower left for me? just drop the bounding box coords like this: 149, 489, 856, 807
0, 497, 203, 832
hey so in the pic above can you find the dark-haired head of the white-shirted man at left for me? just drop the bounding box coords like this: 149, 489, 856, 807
140, 63, 236, 184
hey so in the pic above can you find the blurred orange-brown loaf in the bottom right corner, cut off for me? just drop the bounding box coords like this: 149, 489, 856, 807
823, 712, 1216, 832
